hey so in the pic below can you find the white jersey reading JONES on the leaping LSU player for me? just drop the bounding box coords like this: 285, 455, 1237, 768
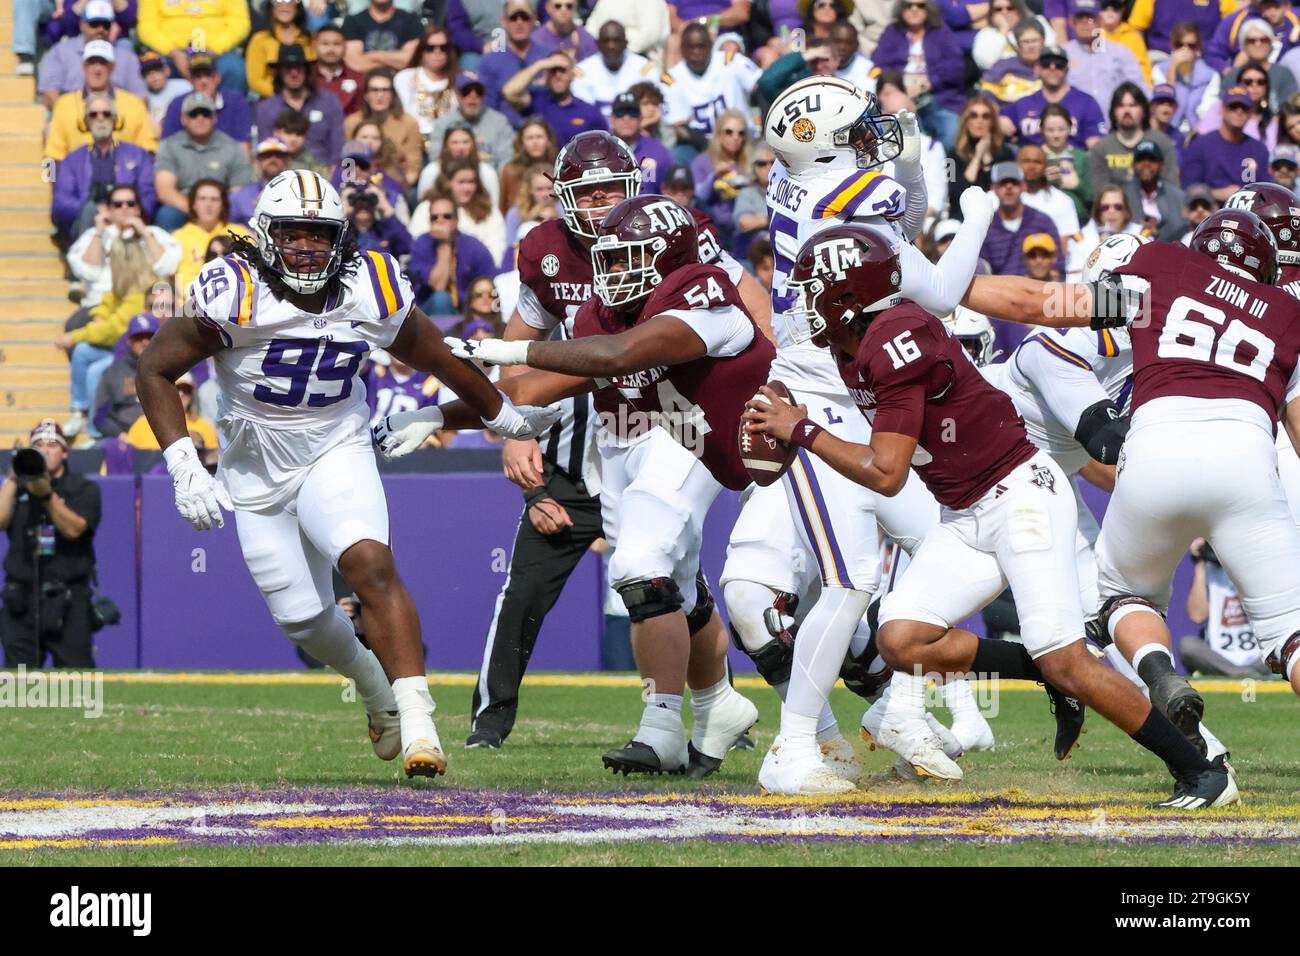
767, 160, 904, 394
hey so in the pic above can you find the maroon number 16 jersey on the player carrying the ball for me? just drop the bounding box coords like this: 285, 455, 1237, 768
836, 302, 1037, 509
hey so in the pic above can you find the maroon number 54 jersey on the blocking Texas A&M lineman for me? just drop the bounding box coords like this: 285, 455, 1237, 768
573, 265, 776, 490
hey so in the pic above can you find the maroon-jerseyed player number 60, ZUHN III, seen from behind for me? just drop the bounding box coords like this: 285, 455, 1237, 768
969, 208, 1300, 754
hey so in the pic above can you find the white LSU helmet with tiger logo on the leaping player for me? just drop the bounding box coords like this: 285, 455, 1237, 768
764, 77, 902, 176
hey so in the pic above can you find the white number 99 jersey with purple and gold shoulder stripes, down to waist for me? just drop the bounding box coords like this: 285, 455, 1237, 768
189, 251, 415, 510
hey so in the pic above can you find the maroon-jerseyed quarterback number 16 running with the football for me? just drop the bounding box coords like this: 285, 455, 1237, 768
746, 225, 1236, 809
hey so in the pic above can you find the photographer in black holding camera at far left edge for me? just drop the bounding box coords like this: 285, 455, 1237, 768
0, 419, 100, 667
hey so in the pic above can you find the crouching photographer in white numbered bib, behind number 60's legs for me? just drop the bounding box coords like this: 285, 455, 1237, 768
1178, 537, 1270, 678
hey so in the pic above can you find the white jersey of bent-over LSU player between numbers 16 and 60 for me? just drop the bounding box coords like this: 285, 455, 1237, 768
982, 328, 1134, 475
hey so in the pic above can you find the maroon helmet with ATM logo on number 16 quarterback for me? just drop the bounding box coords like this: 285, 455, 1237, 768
788, 225, 902, 337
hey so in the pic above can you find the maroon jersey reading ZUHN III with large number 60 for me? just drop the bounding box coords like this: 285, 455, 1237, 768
1114, 242, 1300, 421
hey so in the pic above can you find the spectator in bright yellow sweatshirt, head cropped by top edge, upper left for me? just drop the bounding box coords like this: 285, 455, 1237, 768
137, 0, 251, 94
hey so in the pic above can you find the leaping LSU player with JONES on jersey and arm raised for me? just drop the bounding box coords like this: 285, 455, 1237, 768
722, 77, 991, 793
